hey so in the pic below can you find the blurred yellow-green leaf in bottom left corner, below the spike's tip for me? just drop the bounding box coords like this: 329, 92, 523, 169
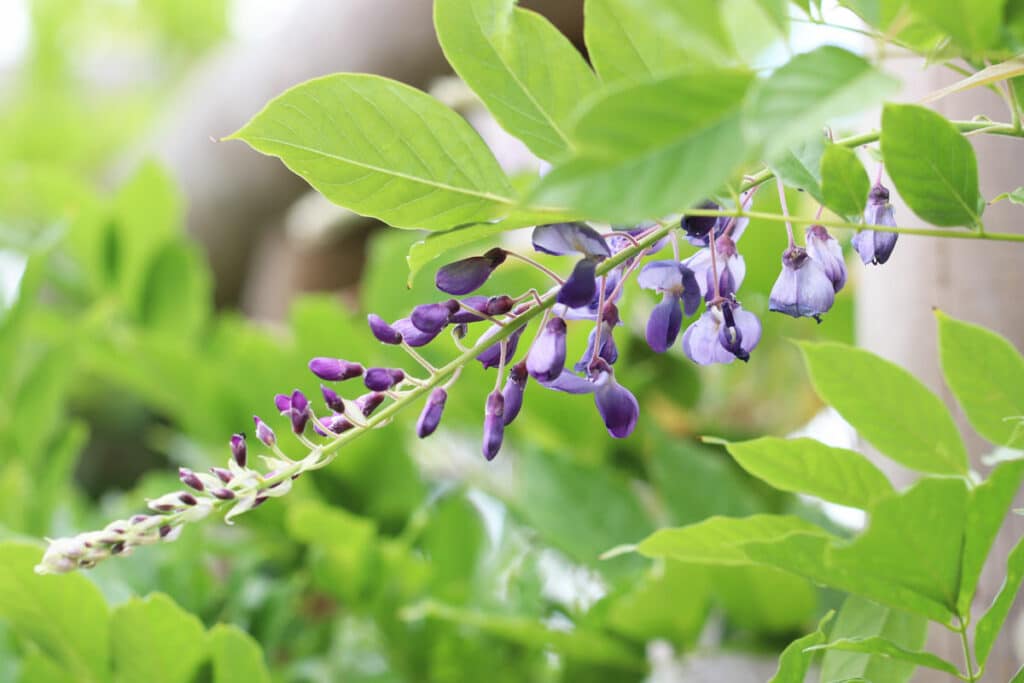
0, 543, 111, 683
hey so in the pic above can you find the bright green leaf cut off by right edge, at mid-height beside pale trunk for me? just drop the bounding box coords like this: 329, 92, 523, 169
935, 310, 1024, 447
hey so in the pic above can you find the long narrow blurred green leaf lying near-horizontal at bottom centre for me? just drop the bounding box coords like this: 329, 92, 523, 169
402, 600, 644, 671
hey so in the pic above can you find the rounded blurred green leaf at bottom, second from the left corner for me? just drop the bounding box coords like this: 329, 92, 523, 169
111, 593, 207, 683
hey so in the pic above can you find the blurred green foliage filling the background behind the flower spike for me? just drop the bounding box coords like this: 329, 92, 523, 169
0, 0, 864, 682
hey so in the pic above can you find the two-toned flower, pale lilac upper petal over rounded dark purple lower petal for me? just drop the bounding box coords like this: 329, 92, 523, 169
637, 261, 700, 353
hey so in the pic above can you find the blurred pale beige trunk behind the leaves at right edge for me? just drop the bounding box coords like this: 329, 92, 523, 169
854, 55, 1024, 683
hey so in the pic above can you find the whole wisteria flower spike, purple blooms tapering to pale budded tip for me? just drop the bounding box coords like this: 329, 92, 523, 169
37, 174, 897, 573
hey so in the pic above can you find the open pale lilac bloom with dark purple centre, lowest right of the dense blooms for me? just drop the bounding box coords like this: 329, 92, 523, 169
683, 301, 761, 366
